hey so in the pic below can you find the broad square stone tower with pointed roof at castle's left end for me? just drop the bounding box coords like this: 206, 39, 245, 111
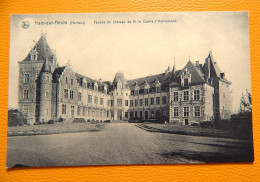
18, 34, 57, 124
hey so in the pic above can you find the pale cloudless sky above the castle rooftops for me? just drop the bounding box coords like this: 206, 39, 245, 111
8, 12, 251, 112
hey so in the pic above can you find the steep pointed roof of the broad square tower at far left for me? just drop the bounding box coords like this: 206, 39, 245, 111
23, 35, 54, 61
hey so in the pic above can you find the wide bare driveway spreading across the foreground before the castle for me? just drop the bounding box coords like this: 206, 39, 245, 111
7, 123, 254, 167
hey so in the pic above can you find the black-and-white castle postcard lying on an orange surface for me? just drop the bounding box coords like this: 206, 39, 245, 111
6, 12, 254, 168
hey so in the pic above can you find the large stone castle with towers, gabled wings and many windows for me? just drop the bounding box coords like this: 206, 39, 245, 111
18, 35, 232, 125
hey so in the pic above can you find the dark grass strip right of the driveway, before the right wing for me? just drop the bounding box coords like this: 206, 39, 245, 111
136, 123, 252, 139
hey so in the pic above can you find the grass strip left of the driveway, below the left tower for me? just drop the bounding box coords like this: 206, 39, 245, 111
8, 123, 106, 136
